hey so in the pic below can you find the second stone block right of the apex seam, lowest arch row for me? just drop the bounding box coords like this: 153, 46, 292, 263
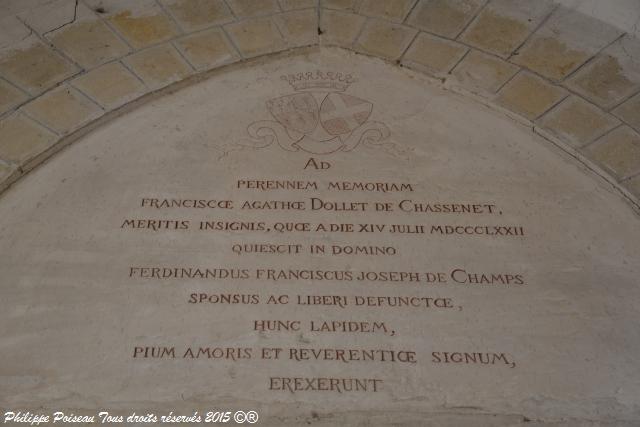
355, 19, 416, 60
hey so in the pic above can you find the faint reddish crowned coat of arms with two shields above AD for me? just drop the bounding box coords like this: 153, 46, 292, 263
241, 71, 389, 154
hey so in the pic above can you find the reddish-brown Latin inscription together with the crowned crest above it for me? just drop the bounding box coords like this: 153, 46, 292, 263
120, 71, 531, 394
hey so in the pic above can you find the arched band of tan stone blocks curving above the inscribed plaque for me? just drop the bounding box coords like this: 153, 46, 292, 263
0, 0, 640, 211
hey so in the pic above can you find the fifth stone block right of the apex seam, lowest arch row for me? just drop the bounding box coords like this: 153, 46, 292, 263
496, 71, 567, 120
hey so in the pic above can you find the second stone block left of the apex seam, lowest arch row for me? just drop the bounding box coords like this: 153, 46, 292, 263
226, 18, 286, 57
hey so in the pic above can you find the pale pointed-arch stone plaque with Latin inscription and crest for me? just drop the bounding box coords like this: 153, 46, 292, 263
0, 49, 640, 426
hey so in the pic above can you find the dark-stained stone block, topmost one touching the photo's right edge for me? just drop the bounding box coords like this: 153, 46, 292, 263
567, 36, 640, 109
